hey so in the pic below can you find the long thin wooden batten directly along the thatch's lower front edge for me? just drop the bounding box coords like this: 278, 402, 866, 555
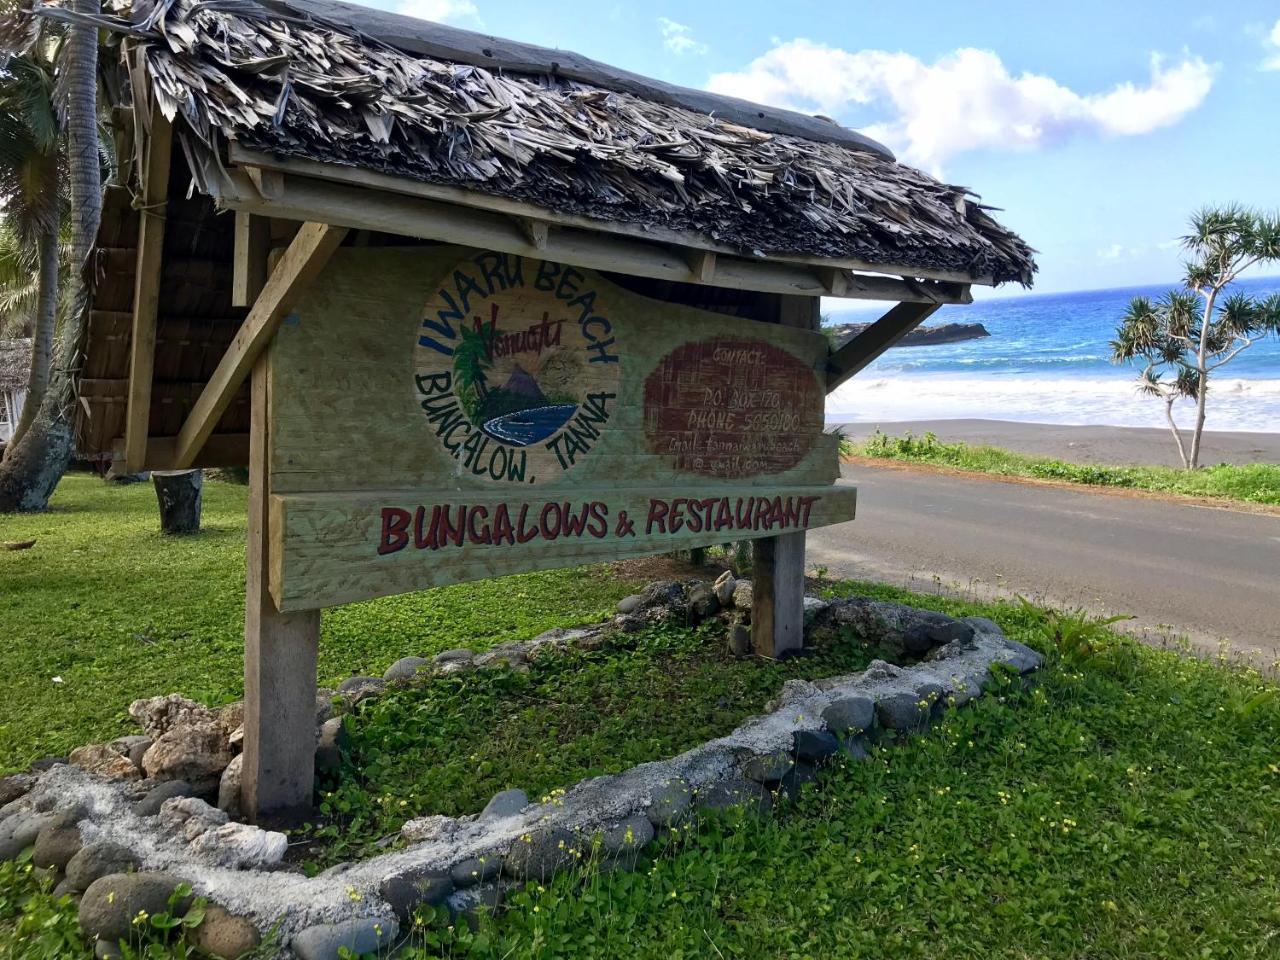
228, 143, 995, 285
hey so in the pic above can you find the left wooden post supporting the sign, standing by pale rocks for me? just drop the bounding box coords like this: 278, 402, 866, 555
241, 349, 320, 824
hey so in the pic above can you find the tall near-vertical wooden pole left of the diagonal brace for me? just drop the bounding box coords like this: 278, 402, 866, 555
124, 108, 173, 474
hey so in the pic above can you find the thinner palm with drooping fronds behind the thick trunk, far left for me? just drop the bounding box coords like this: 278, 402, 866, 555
0, 44, 65, 451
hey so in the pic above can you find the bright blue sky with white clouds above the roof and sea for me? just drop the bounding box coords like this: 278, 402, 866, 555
364, 0, 1280, 294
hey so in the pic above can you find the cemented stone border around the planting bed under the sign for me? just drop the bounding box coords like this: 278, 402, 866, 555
0, 584, 1042, 960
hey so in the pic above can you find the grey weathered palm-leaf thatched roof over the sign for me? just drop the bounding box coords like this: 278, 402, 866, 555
90, 0, 1034, 283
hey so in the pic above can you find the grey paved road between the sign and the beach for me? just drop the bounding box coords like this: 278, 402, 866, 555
808, 465, 1280, 663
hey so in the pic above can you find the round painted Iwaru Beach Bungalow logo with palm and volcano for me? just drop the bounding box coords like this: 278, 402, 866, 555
413, 252, 621, 484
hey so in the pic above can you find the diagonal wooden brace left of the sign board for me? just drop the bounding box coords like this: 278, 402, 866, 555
173, 223, 347, 470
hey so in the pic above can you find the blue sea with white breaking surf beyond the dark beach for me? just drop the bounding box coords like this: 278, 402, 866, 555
826, 276, 1280, 433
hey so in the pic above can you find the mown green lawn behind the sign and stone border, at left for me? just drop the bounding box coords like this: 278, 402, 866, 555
0, 475, 635, 771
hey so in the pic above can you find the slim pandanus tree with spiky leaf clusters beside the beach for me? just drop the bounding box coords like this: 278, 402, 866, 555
1111, 206, 1280, 470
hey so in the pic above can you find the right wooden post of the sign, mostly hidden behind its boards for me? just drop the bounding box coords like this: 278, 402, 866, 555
751, 296, 822, 658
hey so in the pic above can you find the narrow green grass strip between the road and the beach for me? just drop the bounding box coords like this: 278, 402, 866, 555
842, 430, 1280, 504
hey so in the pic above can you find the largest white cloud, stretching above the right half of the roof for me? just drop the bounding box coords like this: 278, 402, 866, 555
708, 40, 1216, 172
